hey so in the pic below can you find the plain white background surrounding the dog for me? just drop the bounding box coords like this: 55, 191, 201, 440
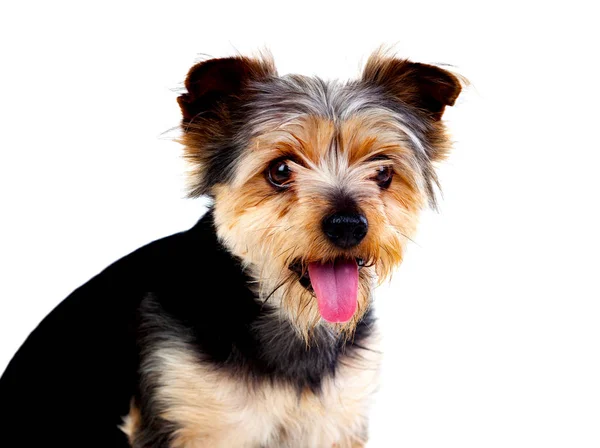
0, 0, 600, 448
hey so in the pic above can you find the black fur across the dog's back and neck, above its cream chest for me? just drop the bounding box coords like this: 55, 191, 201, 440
0, 213, 373, 447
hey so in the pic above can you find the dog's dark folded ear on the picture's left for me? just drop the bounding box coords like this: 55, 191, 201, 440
177, 56, 277, 124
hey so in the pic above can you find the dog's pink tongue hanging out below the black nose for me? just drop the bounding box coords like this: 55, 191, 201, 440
308, 260, 358, 322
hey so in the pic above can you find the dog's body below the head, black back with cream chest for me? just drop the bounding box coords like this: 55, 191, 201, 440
0, 213, 377, 447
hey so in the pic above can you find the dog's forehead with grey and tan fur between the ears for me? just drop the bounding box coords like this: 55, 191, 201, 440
248, 75, 426, 159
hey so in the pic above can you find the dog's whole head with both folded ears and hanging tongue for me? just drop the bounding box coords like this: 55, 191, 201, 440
179, 55, 461, 336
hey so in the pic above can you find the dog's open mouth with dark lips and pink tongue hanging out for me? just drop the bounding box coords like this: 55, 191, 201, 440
289, 257, 365, 323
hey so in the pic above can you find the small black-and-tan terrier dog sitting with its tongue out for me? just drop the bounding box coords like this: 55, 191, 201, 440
0, 52, 461, 448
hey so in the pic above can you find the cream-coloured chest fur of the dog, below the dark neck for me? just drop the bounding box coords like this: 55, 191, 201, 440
147, 340, 378, 448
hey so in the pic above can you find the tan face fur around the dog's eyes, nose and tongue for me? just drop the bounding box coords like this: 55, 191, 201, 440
213, 115, 425, 337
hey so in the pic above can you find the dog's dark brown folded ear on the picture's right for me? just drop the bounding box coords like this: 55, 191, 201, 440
362, 53, 461, 121
